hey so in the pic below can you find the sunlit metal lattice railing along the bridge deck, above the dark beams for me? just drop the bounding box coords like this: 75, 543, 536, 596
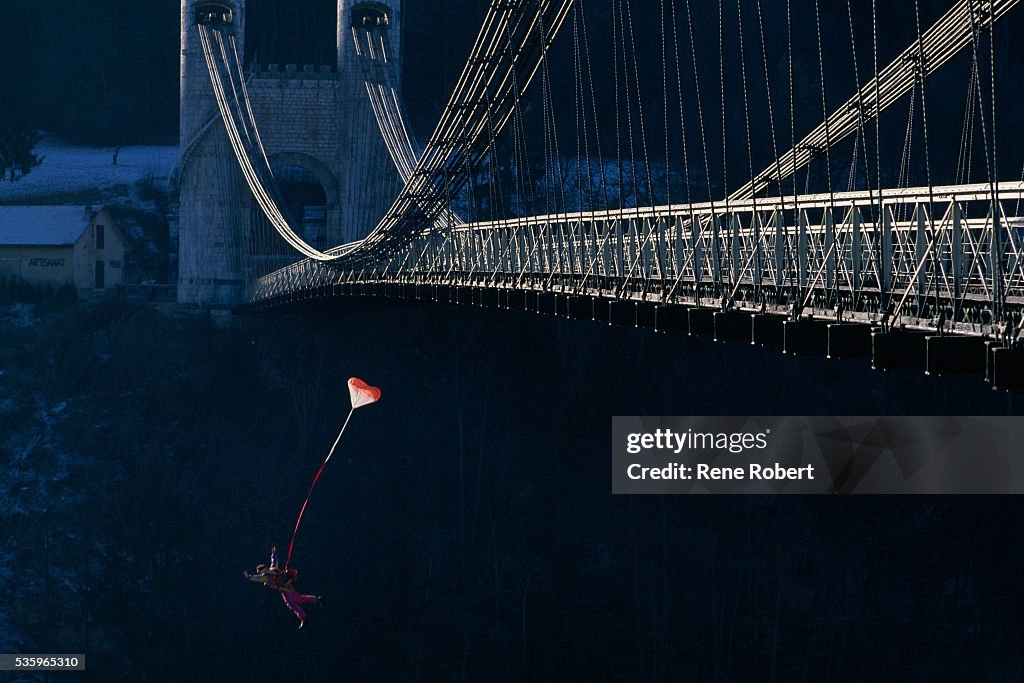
250, 182, 1024, 331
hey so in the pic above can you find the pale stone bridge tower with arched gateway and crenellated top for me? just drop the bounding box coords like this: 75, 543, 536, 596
170, 0, 401, 306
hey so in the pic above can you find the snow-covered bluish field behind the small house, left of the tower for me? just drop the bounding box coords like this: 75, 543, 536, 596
0, 136, 178, 204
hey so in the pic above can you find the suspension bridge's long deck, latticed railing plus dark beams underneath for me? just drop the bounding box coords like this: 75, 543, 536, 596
239, 182, 1024, 388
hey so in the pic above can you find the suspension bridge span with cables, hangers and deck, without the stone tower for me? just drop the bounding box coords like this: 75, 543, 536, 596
172, 0, 1024, 389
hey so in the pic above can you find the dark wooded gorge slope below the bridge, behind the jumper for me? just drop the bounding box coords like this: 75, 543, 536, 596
0, 305, 1024, 681
